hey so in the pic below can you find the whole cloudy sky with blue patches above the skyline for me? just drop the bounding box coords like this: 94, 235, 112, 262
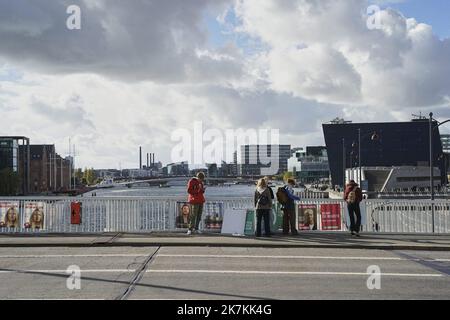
0, 0, 450, 168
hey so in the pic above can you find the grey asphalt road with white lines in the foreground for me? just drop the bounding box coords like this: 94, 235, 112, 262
0, 247, 450, 299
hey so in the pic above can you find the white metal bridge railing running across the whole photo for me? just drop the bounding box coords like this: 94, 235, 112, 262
0, 197, 450, 233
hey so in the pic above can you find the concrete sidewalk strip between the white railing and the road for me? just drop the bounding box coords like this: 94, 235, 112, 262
0, 232, 450, 251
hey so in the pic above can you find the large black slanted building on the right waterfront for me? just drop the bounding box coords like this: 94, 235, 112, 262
323, 120, 447, 190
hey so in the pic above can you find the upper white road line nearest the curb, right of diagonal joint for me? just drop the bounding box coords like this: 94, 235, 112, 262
158, 254, 450, 262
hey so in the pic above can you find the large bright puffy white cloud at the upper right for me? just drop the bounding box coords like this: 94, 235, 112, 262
236, 0, 450, 110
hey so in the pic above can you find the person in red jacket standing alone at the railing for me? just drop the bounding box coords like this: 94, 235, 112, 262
187, 172, 205, 235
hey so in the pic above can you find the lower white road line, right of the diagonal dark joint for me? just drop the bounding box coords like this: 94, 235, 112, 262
146, 269, 444, 277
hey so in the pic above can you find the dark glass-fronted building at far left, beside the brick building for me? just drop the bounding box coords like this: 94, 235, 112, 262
0, 137, 30, 194
